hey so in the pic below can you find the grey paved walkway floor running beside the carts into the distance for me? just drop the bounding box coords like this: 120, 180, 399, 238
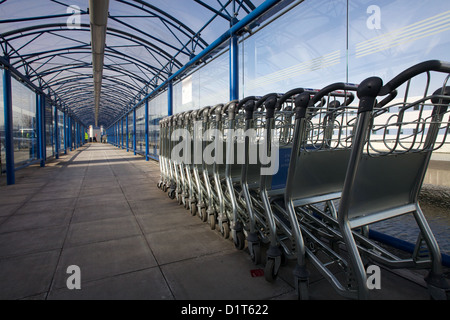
0, 143, 438, 300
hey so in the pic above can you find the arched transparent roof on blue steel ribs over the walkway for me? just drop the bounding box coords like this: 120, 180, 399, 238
0, 0, 283, 126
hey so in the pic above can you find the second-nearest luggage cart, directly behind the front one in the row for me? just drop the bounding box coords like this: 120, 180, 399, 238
280, 83, 364, 298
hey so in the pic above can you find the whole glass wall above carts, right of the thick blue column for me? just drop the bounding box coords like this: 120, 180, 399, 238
240, 0, 450, 97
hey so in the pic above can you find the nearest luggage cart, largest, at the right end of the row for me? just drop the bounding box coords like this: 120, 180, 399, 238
338, 60, 450, 299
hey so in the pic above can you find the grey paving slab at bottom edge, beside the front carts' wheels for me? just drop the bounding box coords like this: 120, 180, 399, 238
161, 249, 293, 300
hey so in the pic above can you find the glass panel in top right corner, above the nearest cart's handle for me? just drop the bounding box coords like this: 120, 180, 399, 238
349, 0, 450, 85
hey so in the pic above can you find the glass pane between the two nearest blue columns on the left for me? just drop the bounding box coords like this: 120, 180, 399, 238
11, 78, 38, 167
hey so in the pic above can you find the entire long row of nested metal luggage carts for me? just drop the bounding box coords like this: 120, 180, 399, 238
158, 60, 450, 299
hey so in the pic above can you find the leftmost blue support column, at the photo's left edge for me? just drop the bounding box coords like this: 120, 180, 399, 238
3, 58, 16, 185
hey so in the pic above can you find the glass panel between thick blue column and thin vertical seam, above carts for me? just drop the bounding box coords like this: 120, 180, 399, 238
240, 0, 347, 97
